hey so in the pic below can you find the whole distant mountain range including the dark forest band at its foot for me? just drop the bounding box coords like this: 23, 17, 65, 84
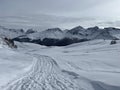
0, 26, 120, 46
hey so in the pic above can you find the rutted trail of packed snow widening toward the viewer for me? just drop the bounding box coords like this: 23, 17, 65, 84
5, 56, 83, 90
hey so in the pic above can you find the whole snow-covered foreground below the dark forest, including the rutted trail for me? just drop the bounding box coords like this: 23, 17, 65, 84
0, 40, 120, 90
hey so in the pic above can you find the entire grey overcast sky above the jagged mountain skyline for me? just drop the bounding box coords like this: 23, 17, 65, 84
0, 0, 120, 30
